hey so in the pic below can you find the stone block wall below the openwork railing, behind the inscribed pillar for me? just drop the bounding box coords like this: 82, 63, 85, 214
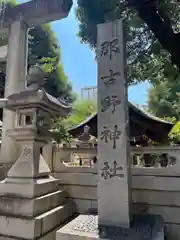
54, 168, 180, 240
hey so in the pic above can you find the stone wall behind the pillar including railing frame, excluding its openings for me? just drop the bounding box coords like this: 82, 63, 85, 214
44, 147, 180, 240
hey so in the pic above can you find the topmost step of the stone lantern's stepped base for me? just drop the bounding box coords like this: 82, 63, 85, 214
0, 176, 59, 198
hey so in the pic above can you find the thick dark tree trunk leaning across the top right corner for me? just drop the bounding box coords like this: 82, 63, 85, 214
128, 0, 180, 68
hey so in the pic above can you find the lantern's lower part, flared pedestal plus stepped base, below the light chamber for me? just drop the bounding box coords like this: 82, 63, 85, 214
0, 128, 73, 240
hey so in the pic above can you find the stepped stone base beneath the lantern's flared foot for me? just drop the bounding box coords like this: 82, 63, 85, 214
0, 176, 73, 240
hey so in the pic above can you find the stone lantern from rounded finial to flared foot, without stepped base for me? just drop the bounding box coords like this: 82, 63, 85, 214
6, 66, 71, 178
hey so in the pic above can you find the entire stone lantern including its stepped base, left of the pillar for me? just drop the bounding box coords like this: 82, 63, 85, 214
0, 66, 74, 240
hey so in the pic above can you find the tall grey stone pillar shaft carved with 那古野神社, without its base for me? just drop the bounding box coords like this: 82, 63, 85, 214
97, 20, 131, 227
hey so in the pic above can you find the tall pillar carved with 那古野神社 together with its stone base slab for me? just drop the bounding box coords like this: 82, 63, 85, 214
56, 20, 164, 240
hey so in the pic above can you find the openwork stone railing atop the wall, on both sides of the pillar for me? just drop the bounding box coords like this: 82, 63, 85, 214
45, 145, 180, 170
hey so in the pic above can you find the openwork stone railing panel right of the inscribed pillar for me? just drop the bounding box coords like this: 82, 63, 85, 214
131, 146, 180, 176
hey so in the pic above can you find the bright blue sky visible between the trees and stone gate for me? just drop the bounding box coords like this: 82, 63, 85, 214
19, 0, 149, 104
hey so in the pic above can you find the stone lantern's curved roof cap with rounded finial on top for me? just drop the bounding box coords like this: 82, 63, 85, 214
6, 65, 72, 117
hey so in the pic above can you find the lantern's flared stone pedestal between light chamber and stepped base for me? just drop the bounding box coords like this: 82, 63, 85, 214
7, 128, 50, 178
